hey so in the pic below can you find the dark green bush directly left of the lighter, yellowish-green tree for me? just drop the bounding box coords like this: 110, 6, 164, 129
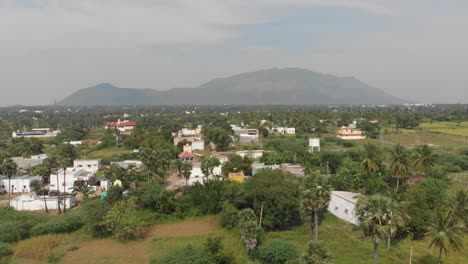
82, 199, 112, 237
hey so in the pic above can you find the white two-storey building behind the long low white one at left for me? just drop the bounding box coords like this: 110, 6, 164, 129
50, 167, 95, 192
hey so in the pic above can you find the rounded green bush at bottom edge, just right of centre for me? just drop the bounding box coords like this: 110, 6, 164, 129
258, 239, 299, 264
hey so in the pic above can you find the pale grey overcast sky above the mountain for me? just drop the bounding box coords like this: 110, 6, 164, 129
0, 0, 468, 106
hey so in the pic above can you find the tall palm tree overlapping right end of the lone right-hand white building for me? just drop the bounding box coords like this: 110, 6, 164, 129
356, 194, 394, 264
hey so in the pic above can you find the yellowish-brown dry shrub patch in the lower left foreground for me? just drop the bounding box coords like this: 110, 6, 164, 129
15, 234, 70, 260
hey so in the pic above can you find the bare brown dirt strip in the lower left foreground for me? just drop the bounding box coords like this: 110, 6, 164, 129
63, 219, 216, 264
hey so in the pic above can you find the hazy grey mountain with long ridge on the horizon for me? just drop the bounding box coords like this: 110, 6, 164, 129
58, 68, 406, 106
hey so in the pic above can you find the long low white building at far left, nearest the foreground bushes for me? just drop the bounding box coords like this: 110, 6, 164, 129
10, 194, 76, 211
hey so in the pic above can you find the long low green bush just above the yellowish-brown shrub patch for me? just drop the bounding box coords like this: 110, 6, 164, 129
31, 213, 83, 236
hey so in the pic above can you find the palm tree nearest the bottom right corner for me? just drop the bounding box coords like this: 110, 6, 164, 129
427, 212, 463, 264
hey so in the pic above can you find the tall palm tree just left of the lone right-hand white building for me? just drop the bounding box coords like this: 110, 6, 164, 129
301, 175, 331, 241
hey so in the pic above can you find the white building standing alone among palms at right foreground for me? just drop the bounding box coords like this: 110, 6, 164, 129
328, 191, 361, 225
